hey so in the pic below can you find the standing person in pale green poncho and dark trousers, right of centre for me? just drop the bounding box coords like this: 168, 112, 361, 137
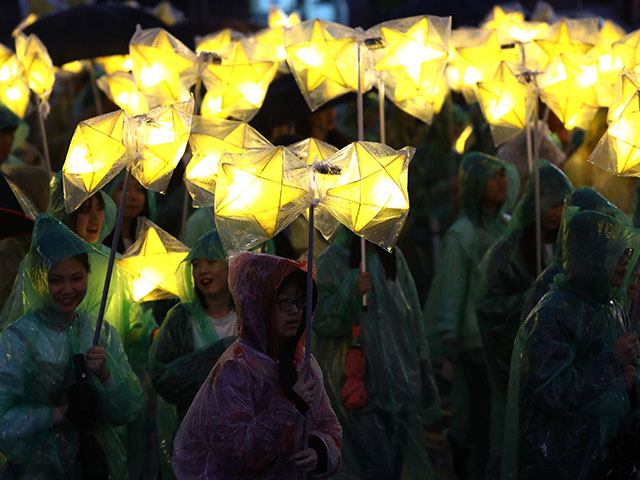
424, 152, 520, 478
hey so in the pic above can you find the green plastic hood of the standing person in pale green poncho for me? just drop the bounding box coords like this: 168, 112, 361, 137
458, 152, 520, 220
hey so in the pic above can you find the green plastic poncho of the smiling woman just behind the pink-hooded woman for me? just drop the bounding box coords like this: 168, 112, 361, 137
149, 231, 237, 418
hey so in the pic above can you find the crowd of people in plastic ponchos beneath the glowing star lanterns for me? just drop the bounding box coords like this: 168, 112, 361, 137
0, 68, 640, 480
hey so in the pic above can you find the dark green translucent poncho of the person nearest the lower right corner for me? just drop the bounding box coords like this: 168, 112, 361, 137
502, 211, 638, 479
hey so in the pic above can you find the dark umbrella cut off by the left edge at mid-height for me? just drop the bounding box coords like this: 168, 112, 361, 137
0, 174, 36, 239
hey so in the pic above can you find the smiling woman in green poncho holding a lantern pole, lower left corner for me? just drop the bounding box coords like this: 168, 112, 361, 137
0, 215, 142, 479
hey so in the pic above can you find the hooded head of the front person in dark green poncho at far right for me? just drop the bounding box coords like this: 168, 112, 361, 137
560, 211, 639, 299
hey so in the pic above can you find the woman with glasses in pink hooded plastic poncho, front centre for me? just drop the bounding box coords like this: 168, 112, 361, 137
173, 252, 342, 480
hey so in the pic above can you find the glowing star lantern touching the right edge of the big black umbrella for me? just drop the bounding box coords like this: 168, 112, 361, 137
129, 28, 198, 106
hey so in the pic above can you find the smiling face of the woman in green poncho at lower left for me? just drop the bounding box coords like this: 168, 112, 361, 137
48, 257, 88, 320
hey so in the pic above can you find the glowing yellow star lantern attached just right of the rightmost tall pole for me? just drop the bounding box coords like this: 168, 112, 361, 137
538, 54, 598, 130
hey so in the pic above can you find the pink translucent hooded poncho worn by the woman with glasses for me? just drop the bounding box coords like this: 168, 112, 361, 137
173, 252, 342, 480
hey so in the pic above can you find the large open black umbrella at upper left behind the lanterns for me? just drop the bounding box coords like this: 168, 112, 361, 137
24, 3, 166, 66
